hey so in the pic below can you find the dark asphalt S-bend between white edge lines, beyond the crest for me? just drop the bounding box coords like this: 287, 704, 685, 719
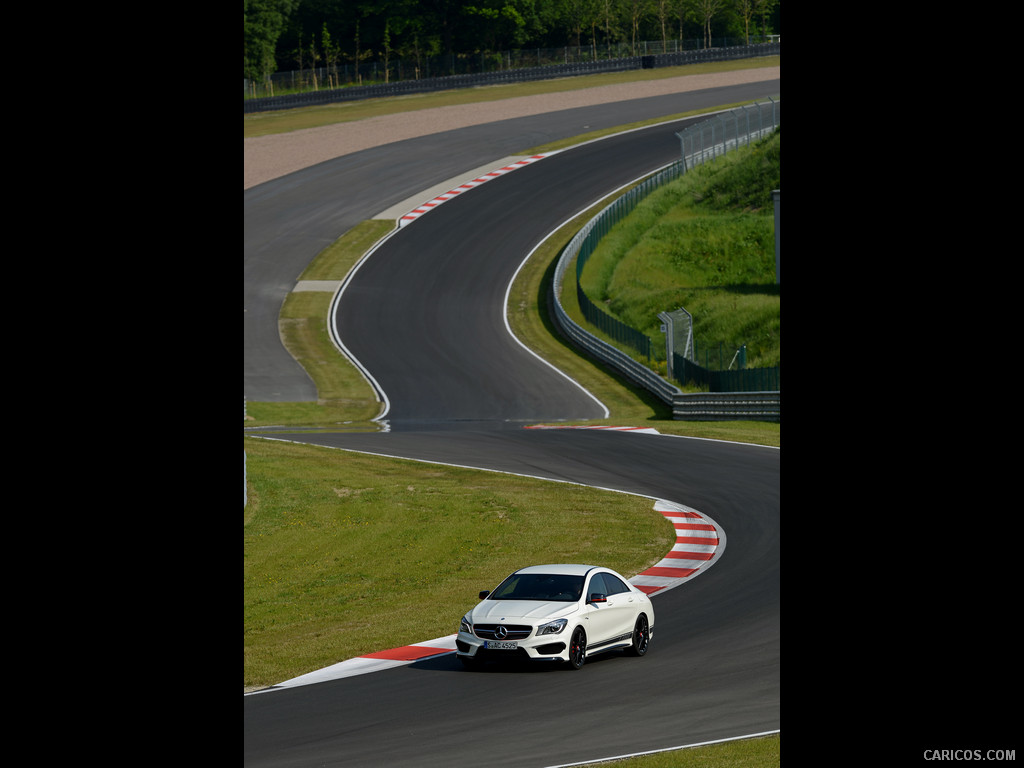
336, 118, 712, 427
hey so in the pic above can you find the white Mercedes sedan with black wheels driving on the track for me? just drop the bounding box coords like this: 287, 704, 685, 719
456, 565, 654, 670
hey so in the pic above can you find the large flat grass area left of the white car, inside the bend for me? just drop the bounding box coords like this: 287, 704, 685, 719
243, 436, 675, 686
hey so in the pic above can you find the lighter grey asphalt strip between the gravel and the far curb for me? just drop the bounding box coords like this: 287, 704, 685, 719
243, 80, 779, 402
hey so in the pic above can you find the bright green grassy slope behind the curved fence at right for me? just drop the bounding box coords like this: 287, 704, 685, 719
581, 131, 781, 368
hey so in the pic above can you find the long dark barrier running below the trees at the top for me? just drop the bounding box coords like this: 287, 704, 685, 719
243, 43, 782, 114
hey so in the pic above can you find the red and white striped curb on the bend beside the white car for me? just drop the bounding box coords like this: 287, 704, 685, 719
246, 501, 725, 696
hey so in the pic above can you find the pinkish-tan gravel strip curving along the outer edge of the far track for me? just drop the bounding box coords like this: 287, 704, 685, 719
243, 67, 780, 189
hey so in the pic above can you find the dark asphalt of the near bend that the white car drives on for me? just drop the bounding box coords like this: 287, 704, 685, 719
245, 430, 780, 768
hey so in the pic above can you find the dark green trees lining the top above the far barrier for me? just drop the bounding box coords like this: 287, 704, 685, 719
243, 0, 780, 80
